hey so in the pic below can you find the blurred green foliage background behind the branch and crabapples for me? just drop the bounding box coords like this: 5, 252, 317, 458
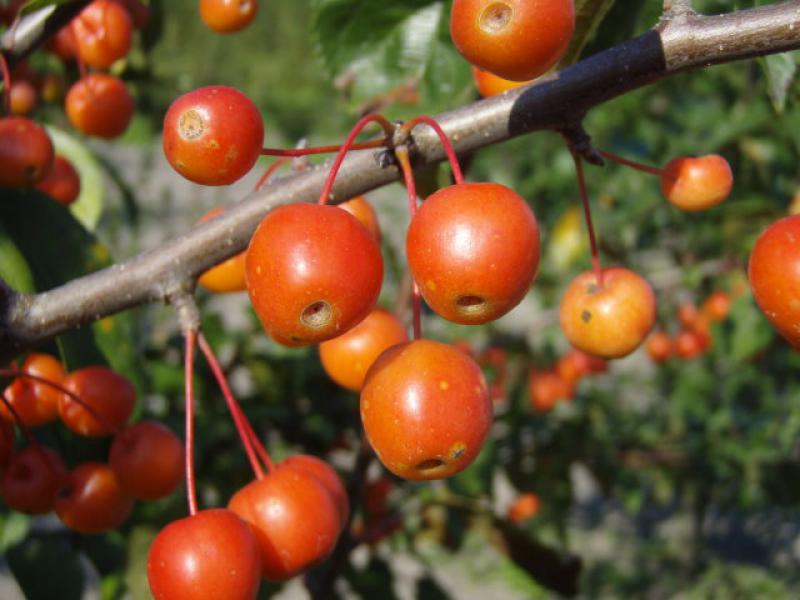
0, 0, 800, 600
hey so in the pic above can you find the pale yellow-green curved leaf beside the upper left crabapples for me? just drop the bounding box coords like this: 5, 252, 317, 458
47, 126, 104, 231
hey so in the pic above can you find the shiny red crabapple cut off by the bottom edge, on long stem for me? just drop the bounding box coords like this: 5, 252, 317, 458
147, 508, 261, 600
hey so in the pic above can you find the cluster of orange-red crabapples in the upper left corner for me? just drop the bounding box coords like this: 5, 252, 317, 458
0, 0, 149, 205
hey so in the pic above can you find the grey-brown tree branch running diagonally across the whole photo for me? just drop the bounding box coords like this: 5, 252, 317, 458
0, 0, 800, 361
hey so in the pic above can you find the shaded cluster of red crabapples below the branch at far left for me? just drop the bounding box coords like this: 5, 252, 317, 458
0, 353, 183, 534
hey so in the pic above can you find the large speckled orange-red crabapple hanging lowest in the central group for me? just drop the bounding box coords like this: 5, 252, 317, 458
361, 340, 492, 480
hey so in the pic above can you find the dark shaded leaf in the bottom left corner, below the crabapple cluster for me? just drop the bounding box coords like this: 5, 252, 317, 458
6, 538, 85, 600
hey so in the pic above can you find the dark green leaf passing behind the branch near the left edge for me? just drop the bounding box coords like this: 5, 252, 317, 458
0, 190, 140, 384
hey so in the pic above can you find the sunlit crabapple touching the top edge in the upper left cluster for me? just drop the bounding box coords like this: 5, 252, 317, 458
72, 0, 133, 69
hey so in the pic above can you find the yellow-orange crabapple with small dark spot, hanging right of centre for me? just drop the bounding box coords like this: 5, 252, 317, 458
560, 267, 656, 358
